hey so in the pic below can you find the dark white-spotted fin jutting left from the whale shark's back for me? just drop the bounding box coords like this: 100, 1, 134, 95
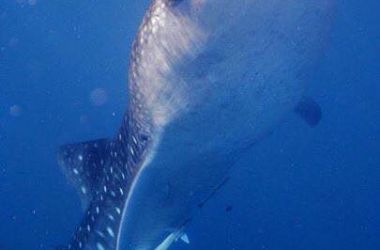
58, 139, 110, 207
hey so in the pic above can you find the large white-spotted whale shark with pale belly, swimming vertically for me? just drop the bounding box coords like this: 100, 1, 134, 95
58, 0, 334, 250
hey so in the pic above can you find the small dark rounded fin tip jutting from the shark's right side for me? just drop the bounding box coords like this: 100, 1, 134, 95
294, 97, 322, 127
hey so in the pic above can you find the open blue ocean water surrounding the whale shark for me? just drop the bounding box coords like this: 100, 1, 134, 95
0, 0, 380, 250
